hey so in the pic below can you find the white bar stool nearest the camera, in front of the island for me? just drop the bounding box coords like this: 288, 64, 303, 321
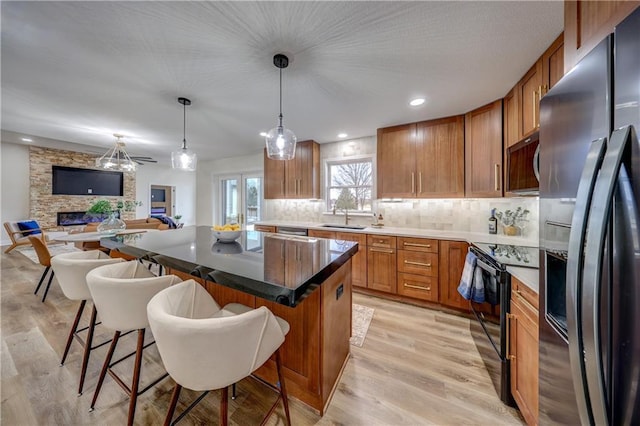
147, 280, 291, 426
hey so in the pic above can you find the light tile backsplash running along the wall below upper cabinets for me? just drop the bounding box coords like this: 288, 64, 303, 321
264, 197, 539, 241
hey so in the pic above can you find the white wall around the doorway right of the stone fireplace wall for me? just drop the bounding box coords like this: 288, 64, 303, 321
136, 163, 197, 225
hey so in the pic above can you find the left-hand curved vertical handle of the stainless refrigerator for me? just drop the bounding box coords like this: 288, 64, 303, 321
566, 138, 606, 424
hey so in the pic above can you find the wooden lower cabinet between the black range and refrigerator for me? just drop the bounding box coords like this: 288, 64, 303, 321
508, 277, 539, 425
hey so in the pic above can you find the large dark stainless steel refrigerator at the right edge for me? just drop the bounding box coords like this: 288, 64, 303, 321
539, 8, 640, 425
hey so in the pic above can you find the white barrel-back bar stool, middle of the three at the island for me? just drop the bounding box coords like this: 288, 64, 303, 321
87, 260, 182, 425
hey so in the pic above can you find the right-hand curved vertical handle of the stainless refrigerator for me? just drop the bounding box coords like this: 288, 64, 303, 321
582, 126, 633, 425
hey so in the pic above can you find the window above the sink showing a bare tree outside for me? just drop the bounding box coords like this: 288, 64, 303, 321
327, 158, 373, 211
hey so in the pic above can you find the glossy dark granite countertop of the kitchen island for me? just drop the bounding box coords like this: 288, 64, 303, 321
100, 226, 358, 306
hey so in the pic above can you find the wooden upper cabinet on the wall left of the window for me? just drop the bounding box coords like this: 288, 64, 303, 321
264, 141, 320, 199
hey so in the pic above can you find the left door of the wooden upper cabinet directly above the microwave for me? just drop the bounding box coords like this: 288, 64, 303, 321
516, 59, 544, 137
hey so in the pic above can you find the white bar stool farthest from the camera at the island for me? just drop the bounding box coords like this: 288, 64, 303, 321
51, 250, 123, 396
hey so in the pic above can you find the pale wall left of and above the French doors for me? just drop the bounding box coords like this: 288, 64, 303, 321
196, 149, 264, 226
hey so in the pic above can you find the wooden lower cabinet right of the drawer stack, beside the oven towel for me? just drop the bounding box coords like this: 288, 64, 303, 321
439, 240, 469, 311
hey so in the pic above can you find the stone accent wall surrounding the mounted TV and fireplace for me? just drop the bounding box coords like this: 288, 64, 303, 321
29, 146, 136, 228
